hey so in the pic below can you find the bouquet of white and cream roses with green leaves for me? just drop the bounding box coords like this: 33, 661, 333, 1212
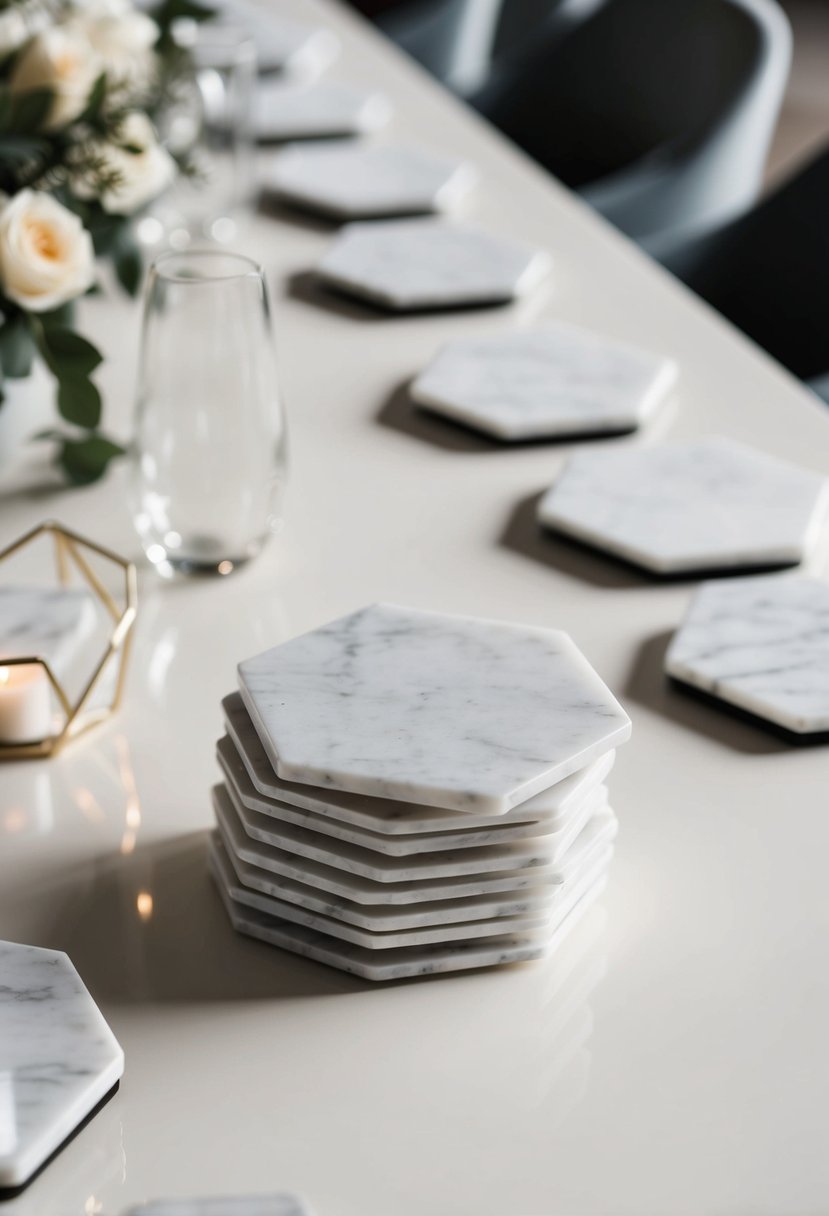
0, 0, 209, 484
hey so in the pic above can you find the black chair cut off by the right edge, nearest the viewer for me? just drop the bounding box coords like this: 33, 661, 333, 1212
660, 148, 829, 394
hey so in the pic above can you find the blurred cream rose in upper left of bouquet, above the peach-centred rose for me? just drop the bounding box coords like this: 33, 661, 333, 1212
10, 26, 103, 130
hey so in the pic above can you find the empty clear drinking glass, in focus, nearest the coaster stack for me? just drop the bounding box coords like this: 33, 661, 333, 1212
132, 250, 287, 576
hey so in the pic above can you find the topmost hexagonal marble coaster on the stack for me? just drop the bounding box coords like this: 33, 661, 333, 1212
238, 604, 631, 815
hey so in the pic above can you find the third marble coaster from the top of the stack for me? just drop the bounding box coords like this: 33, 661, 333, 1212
216, 737, 608, 861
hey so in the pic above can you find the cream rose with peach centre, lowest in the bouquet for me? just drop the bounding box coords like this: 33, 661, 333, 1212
0, 190, 95, 313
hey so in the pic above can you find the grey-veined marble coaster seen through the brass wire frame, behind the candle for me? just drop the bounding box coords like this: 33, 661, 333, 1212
0, 586, 97, 676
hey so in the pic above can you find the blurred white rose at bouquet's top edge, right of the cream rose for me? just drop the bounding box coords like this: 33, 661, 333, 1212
64, 0, 158, 88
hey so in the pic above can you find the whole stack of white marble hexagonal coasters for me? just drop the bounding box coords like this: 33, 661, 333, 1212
210, 604, 631, 980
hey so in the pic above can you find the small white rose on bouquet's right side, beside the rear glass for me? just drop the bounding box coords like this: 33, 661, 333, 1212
71, 111, 177, 215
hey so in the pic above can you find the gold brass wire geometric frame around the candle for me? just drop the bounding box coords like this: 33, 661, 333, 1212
0, 519, 139, 760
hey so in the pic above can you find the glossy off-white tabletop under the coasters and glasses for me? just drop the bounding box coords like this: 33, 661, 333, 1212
0, 0, 829, 1216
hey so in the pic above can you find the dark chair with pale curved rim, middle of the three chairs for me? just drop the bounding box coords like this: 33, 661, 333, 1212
470, 0, 791, 240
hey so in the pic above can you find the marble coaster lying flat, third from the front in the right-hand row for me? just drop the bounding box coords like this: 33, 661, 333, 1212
411, 325, 677, 440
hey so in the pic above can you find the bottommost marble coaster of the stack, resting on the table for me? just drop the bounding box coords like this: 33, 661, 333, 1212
210, 848, 607, 980
